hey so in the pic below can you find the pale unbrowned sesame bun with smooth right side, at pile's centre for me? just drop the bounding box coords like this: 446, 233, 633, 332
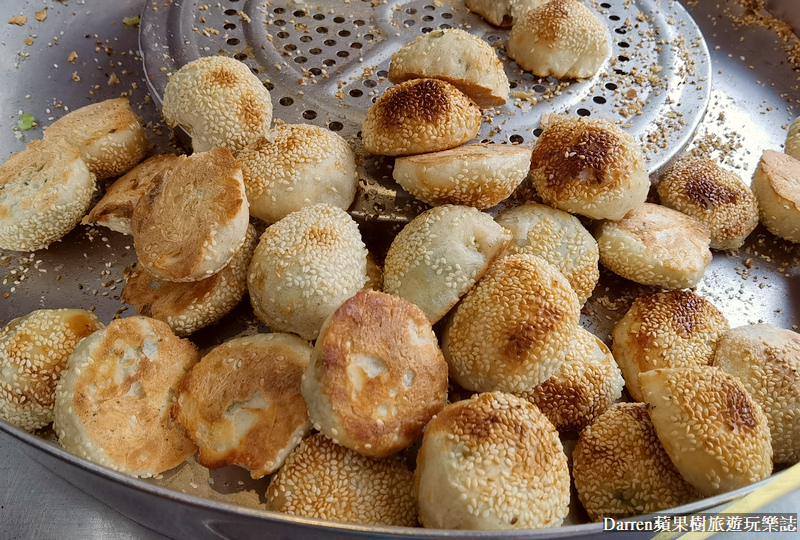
383, 205, 511, 324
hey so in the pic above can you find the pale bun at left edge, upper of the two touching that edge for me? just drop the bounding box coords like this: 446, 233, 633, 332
0, 139, 95, 251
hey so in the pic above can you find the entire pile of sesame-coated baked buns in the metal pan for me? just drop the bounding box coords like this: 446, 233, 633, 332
0, 0, 800, 529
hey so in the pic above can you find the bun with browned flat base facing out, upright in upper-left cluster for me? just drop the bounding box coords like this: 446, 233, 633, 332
131, 148, 250, 282
